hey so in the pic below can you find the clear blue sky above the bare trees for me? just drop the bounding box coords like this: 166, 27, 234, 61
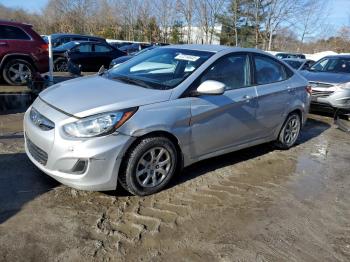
0, 0, 350, 29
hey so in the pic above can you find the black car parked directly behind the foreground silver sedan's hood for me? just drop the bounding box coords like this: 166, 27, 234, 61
64, 41, 125, 72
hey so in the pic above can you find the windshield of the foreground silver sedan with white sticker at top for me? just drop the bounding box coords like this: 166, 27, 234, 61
105, 48, 214, 89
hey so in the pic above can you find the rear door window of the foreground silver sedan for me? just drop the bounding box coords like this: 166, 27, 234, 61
254, 55, 291, 85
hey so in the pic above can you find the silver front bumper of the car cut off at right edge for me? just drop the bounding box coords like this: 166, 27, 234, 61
311, 89, 350, 109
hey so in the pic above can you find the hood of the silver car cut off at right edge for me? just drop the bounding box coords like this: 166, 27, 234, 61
300, 71, 350, 84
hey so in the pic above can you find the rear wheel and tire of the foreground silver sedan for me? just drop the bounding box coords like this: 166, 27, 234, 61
275, 113, 301, 149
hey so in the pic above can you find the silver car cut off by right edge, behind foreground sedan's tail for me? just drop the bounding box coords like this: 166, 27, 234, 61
301, 55, 350, 110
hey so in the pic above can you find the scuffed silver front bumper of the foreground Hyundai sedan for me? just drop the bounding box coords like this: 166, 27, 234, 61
24, 99, 134, 191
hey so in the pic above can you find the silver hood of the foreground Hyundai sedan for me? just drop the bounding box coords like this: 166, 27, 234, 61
39, 75, 171, 117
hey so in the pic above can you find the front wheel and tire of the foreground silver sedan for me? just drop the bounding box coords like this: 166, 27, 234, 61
118, 137, 178, 196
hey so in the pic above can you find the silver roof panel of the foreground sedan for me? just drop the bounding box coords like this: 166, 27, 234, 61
160, 44, 272, 56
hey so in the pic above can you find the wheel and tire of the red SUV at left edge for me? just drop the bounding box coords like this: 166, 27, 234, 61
2, 59, 35, 86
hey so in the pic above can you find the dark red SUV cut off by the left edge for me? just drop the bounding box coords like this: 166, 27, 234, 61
0, 20, 49, 85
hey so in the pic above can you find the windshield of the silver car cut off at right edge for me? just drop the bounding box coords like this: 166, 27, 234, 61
310, 57, 350, 73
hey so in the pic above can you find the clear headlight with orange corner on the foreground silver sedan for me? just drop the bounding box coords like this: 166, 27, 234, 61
63, 108, 137, 137
